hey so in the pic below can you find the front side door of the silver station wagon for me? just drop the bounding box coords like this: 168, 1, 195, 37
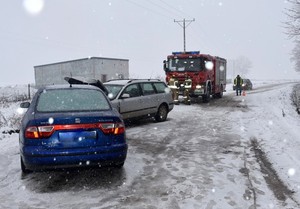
118, 84, 144, 119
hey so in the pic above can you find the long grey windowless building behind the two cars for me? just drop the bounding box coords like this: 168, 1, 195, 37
34, 57, 129, 88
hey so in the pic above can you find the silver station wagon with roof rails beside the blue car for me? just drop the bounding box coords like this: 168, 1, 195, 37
103, 79, 174, 122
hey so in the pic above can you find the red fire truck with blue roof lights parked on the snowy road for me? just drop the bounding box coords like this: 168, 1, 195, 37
164, 51, 227, 102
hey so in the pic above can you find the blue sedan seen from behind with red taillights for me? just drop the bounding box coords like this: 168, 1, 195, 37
19, 85, 128, 173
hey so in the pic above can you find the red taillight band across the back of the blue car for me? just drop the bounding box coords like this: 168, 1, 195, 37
25, 123, 125, 139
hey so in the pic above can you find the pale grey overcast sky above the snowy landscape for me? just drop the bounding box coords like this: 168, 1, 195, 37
0, 0, 300, 85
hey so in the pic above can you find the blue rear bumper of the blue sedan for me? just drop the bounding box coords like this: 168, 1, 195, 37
21, 144, 128, 170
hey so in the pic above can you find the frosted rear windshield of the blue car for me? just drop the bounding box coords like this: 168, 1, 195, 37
36, 88, 110, 112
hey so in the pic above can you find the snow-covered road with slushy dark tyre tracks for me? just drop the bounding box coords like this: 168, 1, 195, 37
0, 80, 300, 209
